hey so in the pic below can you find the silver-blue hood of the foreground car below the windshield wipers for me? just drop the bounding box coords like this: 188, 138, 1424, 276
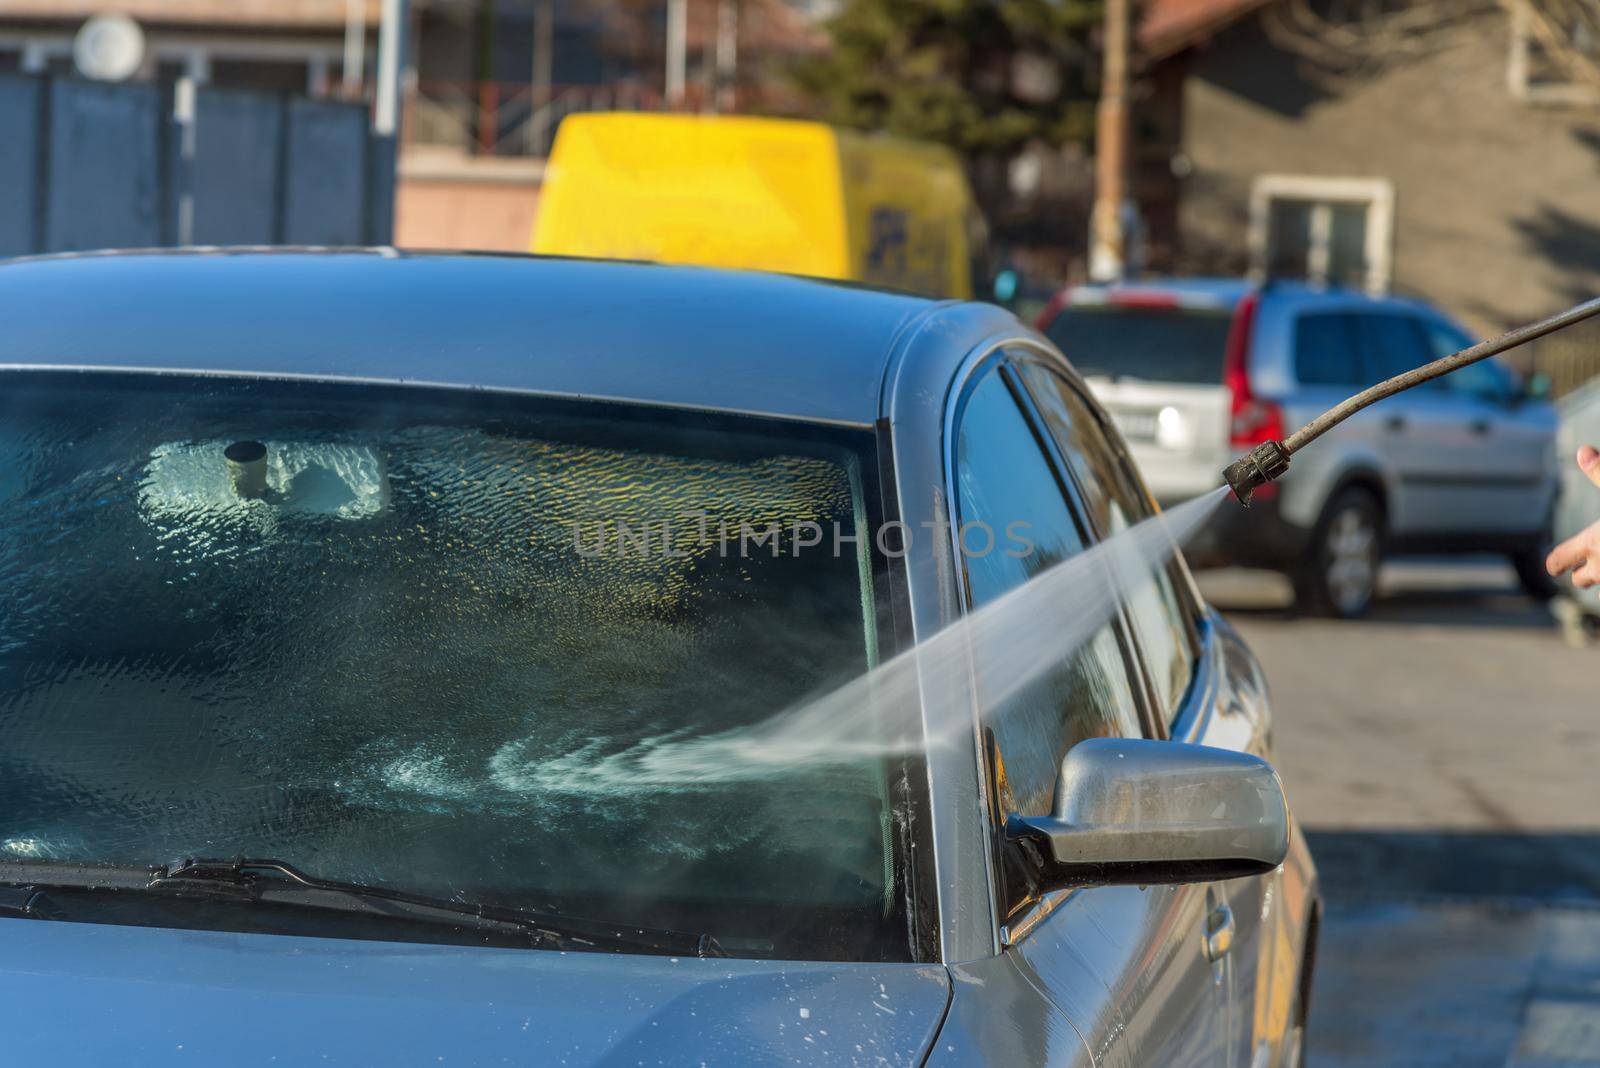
0, 919, 950, 1065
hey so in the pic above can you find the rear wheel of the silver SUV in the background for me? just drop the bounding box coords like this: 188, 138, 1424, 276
1294, 486, 1382, 619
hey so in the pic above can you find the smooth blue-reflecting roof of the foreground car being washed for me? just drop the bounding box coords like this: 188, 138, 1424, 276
0, 249, 938, 424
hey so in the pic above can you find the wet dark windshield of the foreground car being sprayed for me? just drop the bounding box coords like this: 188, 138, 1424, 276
0, 373, 910, 959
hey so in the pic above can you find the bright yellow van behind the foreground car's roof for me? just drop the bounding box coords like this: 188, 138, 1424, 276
533, 112, 974, 297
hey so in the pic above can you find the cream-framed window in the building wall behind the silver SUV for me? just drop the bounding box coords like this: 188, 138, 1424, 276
1250, 174, 1394, 293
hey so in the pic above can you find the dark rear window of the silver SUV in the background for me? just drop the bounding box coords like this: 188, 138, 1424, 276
1045, 305, 1232, 385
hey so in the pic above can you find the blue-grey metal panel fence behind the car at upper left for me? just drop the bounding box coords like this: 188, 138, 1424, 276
0, 75, 394, 256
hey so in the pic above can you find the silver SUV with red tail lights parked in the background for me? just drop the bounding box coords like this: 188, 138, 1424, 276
1038, 278, 1558, 616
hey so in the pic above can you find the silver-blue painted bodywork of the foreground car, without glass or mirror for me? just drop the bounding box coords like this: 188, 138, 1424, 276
0, 253, 1317, 1068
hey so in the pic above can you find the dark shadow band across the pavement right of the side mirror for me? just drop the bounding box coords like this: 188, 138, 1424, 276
1306, 830, 1600, 907
